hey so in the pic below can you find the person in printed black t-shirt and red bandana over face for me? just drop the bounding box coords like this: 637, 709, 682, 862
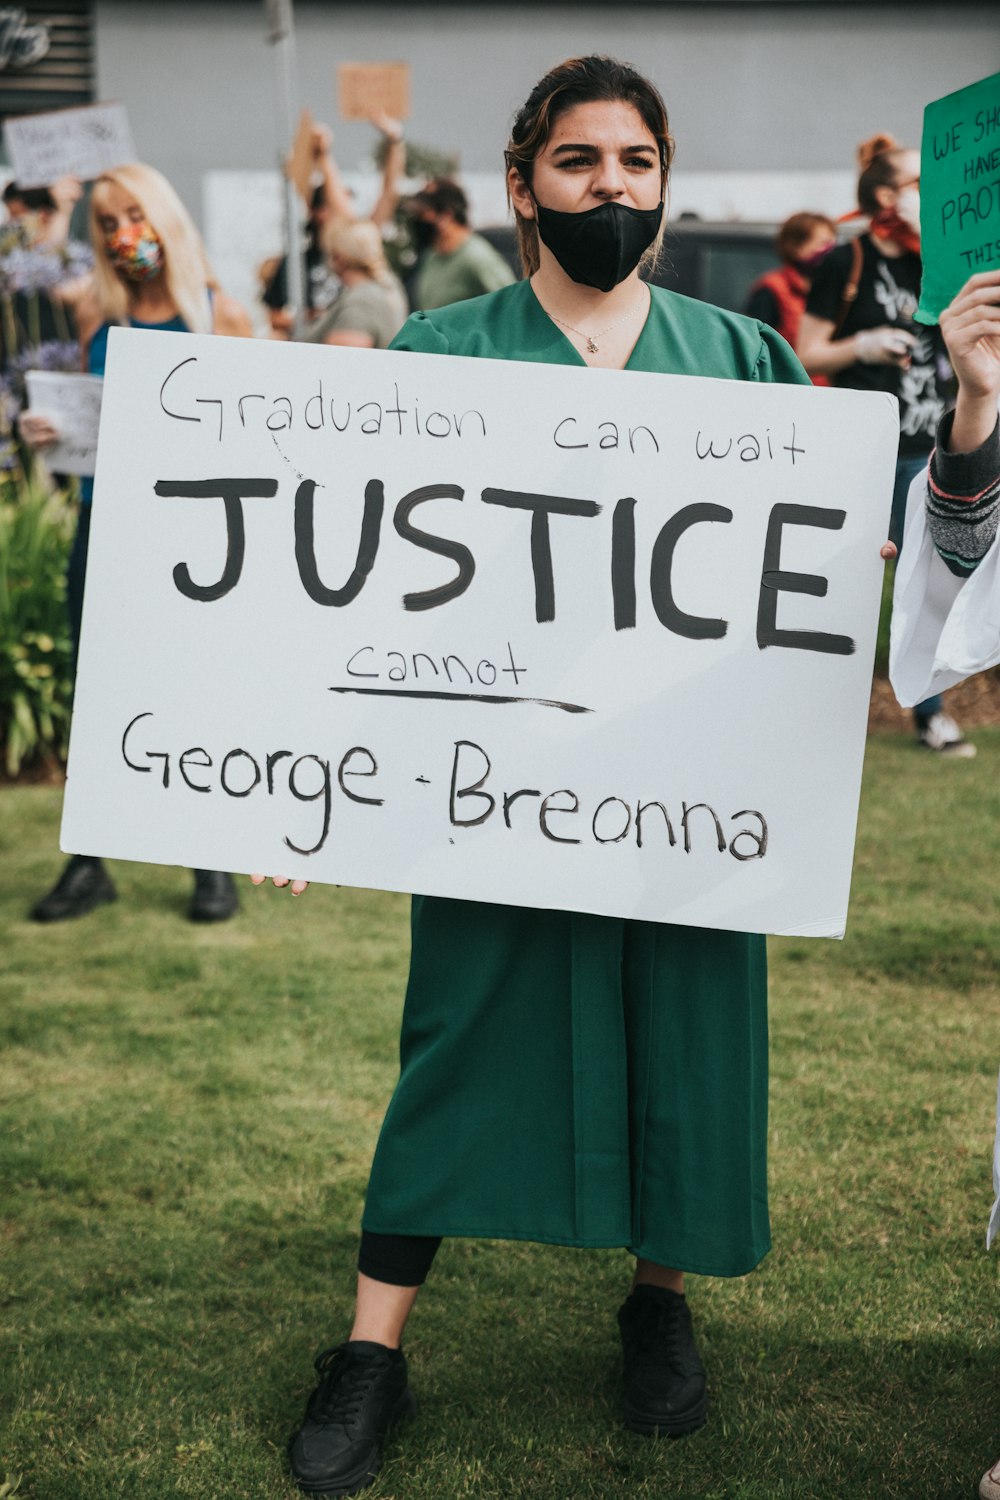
798, 135, 976, 756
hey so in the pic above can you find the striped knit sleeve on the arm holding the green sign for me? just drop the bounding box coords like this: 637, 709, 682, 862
927, 413, 1000, 578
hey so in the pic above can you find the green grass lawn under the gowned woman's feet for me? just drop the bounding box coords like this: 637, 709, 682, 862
0, 729, 1000, 1500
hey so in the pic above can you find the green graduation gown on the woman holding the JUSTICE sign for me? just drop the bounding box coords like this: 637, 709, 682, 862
364, 282, 808, 1275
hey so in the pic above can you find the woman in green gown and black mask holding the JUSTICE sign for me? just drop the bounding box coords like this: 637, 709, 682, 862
255, 57, 808, 1494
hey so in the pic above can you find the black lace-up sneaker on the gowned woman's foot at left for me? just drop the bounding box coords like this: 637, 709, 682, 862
288, 1340, 417, 1496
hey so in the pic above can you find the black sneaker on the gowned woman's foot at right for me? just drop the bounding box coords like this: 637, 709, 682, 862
618, 1286, 708, 1437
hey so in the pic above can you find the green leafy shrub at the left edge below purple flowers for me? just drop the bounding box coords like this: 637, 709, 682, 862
0, 480, 73, 776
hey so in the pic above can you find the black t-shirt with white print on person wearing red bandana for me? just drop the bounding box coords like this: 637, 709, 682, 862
805, 234, 952, 455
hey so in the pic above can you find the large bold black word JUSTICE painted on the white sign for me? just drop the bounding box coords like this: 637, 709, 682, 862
154, 479, 855, 656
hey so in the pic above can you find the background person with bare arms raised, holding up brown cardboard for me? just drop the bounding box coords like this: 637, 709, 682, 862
261, 113, 406, 338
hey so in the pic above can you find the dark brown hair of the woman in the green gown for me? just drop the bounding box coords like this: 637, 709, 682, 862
504, 56, 673, 276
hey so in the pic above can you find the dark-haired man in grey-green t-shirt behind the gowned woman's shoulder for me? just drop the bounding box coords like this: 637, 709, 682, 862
406, 177, 514, 312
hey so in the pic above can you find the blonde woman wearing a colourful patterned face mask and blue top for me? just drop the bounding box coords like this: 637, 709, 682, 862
21, 162, 250, 923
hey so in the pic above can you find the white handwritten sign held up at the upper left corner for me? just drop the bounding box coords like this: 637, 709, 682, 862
3, 104, 135, 188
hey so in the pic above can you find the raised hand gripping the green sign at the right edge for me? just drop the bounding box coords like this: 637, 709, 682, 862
940, 272, 1000, 453
